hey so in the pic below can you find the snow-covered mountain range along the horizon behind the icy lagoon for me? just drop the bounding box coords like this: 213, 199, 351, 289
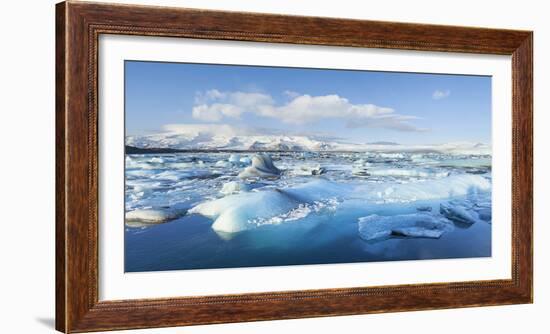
126, 131, 491, 155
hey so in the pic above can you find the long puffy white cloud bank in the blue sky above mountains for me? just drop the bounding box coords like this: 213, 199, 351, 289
192, 89, 426, 131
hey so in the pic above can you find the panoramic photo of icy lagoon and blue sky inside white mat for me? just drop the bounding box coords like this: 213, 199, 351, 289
124, 60, 492, 272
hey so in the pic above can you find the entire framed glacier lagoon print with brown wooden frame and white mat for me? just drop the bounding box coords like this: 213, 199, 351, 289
56, 1, 533, 332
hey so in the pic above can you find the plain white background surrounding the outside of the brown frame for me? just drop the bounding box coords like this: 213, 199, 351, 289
0, 0, 550, 334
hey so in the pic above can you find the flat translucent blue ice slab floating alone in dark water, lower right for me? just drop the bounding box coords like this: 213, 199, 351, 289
358, 213, 453, 241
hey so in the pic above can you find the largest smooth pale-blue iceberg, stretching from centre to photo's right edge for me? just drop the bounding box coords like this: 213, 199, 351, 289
189, 175, 490, 235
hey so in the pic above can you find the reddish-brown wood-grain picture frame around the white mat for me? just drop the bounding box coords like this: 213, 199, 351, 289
56, 1, 533, 333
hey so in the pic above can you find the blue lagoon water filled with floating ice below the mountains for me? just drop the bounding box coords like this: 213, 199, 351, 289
125, 152, 491, 272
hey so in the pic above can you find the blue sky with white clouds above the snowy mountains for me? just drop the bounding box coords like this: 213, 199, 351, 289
125, 61, 491, 144
